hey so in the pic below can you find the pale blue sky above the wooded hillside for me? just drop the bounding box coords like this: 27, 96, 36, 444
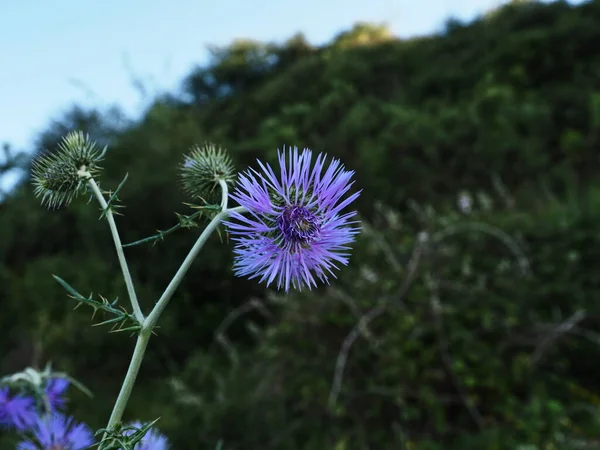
0, 0, 584, 154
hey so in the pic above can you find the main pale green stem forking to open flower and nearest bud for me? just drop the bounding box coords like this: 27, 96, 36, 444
105, 182, 246, 437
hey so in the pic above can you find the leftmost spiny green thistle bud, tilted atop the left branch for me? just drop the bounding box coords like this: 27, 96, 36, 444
31, 131, 106, 209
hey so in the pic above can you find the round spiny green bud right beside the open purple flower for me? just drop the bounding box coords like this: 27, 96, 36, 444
181, 143, 235, 204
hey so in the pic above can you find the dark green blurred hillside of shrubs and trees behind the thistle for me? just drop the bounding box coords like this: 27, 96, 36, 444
0, 1, 600, 450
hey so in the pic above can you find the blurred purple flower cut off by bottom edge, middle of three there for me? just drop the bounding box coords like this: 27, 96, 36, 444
17, 414, 94, 450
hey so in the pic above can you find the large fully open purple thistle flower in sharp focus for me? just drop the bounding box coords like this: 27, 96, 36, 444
225, 148, 360, 292
